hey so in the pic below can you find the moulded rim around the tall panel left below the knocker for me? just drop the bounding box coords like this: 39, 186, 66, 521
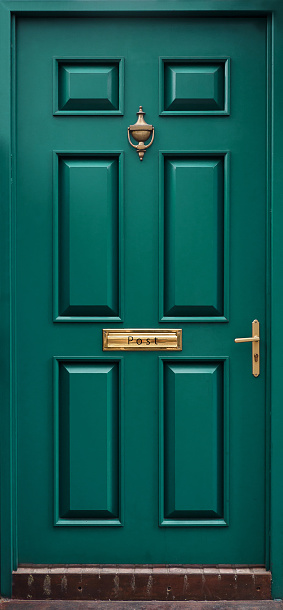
52, 150, 125, 323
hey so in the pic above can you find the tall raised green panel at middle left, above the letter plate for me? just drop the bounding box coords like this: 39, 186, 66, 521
54, 153, 122, 322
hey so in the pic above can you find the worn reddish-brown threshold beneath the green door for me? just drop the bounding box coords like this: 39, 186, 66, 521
12, 564, 272, 601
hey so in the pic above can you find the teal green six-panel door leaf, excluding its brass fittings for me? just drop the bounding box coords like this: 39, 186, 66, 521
15, 16, 267, 565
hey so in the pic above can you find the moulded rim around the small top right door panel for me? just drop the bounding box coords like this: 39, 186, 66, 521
159, 56, 231, 116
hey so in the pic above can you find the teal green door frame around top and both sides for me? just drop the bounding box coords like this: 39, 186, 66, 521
0, 0, 283, 599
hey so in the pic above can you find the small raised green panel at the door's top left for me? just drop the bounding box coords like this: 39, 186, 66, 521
53, 58, 124, 115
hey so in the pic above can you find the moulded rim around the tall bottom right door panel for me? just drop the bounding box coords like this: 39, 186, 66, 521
158, 356, 230, 527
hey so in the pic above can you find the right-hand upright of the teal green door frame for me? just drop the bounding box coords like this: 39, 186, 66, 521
270, 9, 283, 598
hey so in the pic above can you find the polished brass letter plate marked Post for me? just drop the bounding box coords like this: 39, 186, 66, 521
102, 328, 182, 352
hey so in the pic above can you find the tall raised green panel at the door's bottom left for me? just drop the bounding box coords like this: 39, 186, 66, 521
55, 359, 121, 525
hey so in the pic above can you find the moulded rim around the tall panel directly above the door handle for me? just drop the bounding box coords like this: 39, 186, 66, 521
158, 150, 231, 324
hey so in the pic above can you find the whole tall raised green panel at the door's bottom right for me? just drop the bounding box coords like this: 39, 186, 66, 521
160, 360, 228, 526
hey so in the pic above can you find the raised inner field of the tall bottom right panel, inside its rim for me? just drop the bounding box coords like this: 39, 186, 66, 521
164, 363, 223, 520
